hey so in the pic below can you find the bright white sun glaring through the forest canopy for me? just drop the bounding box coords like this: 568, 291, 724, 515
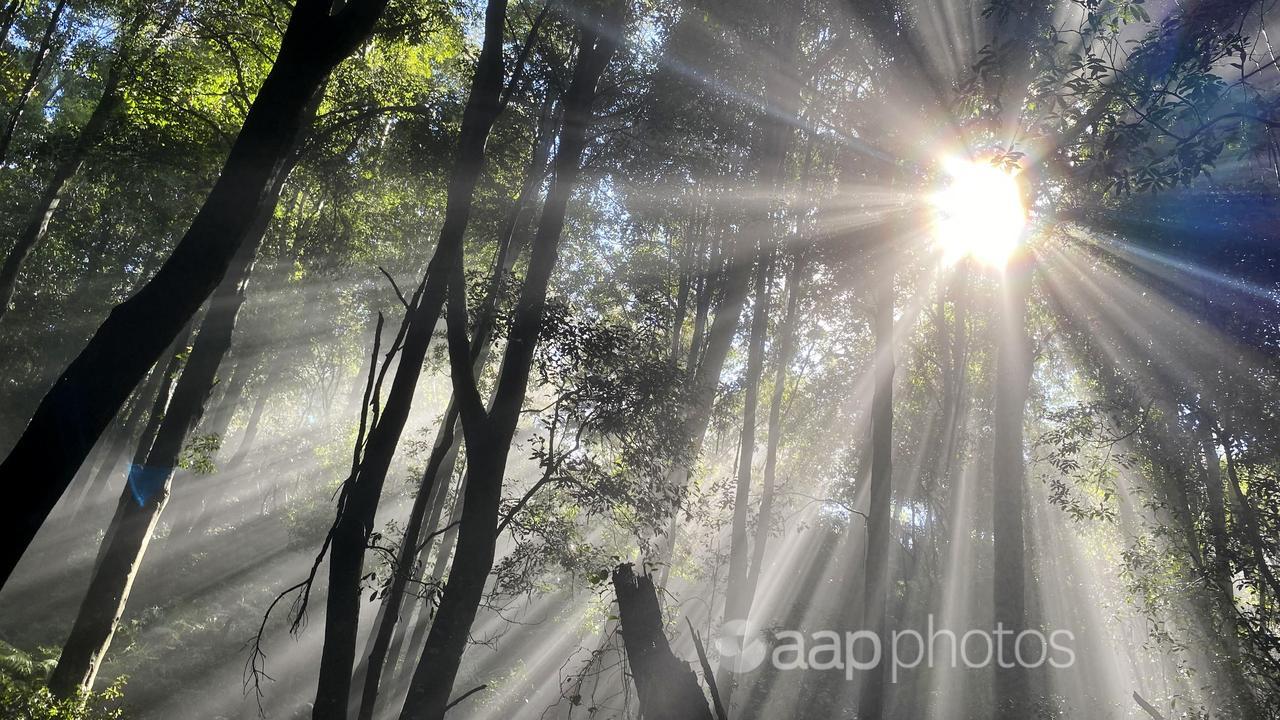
932, 159, 1027, 268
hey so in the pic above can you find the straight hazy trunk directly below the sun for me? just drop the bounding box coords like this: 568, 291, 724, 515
992, 260, 1032, 720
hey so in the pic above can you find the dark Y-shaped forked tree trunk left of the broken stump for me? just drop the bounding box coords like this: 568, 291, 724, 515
401, 14, 622, 720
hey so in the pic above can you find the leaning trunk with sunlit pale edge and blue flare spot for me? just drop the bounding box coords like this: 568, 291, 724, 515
49, 174, 276, 698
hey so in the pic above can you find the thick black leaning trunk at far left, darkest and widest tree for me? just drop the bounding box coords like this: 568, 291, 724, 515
0, 0, 385, 583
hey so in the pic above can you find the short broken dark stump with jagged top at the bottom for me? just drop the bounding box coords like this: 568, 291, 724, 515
613, 565, 712, 720
